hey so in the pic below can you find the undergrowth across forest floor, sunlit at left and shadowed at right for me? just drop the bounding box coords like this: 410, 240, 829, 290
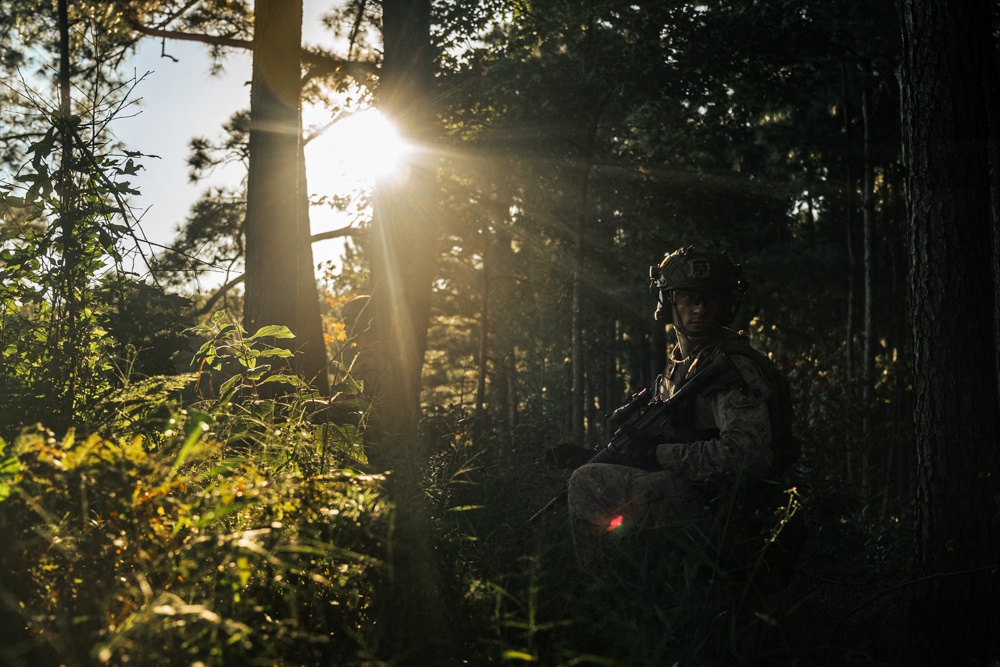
0, 352, 907, 666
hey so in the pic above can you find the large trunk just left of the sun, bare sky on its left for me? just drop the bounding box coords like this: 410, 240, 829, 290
244, 0, 326, 389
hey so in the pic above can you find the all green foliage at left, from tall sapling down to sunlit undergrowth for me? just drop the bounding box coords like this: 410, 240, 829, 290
0, 58, 391, 664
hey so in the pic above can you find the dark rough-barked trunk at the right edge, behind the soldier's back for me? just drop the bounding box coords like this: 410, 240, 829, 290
901, 0, 1000, 665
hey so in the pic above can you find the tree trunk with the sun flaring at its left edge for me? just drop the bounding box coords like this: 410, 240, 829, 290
363, 0, 452, 665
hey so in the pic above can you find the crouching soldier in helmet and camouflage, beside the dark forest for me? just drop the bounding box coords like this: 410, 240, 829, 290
568, 246, 774, 567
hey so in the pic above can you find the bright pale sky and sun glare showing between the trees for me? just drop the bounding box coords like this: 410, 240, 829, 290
106, 0, 400, 276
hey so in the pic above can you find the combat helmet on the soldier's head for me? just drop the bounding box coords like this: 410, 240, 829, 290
649, 245, 746, 326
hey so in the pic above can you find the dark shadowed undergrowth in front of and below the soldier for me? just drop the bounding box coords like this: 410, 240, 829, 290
429, 408, 909, 666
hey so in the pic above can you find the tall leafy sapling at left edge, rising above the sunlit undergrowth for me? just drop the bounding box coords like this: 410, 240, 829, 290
0, 96, 193, 437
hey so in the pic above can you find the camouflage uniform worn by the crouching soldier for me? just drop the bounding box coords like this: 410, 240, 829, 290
569, 329, 771, 566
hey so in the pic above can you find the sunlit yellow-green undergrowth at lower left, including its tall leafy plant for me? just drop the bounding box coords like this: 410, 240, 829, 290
0, 317, 392, 665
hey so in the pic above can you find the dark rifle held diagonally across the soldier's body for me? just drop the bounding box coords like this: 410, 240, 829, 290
528, 352, 739, 523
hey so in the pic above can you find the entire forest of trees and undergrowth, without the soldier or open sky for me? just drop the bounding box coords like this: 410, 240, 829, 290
0, 0, 1000, 667
